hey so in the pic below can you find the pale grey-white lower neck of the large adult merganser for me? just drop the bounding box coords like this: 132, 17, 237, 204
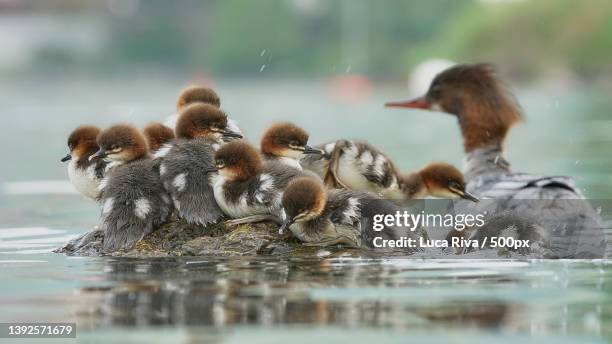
463, 143, 510, 182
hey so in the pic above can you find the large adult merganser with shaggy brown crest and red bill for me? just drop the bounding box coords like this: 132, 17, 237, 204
386, 64, 605, 258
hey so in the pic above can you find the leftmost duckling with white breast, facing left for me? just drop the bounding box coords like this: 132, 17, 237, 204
61, 125, 106, 200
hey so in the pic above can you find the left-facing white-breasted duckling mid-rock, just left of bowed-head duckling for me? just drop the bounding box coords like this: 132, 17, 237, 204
209, 141, 305, 224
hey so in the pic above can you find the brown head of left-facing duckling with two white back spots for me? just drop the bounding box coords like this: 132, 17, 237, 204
89, 124, 148, 162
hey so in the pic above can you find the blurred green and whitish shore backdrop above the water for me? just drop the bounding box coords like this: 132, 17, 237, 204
0, 0, 612, 82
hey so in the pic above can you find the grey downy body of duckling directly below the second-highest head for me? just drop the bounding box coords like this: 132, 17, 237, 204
159, 139, 223, 226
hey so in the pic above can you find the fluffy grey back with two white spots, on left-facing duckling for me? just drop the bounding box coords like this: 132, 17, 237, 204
99, 159, 172, 253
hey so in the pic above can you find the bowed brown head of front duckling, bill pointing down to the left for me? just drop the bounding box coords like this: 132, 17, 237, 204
280, 177, 327, 232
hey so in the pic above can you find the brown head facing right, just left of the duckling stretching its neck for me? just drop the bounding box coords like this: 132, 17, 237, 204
261, 123, 324, 159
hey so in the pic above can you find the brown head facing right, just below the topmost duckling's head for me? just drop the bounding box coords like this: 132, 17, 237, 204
175, 103, 242, 141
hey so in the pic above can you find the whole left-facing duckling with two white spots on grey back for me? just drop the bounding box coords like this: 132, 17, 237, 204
92, 124, 172, 253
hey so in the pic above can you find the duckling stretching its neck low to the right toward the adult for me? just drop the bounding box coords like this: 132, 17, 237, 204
300, 140, 478, 202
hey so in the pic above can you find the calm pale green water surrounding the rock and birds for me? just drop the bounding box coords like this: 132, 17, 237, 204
0, 76, 612, 343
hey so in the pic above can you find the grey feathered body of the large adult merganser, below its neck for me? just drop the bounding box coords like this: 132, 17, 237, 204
455, 173, 606, 258
